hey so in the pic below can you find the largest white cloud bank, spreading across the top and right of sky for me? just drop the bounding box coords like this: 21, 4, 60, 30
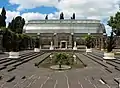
9, 0, 120, 20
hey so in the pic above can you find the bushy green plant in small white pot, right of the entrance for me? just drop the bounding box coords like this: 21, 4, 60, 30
85, 35, 94, 52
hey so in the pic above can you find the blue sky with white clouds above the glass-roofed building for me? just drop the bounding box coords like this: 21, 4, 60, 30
0, 0, 120, 32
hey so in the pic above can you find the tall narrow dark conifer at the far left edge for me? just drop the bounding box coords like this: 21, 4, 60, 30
0, 7, 6, 27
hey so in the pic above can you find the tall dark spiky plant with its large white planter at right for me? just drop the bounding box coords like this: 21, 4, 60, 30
103, 32, 116, 59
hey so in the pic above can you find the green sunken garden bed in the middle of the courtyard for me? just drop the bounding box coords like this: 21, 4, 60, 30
38, 52, 85, 69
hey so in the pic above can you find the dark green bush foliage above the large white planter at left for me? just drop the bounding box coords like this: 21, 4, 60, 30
2, 28, 20, 51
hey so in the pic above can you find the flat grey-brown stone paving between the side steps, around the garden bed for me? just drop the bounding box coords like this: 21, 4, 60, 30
0, 49, 120, 88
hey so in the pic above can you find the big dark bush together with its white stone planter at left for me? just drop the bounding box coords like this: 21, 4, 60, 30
2, 28, 19, 58
